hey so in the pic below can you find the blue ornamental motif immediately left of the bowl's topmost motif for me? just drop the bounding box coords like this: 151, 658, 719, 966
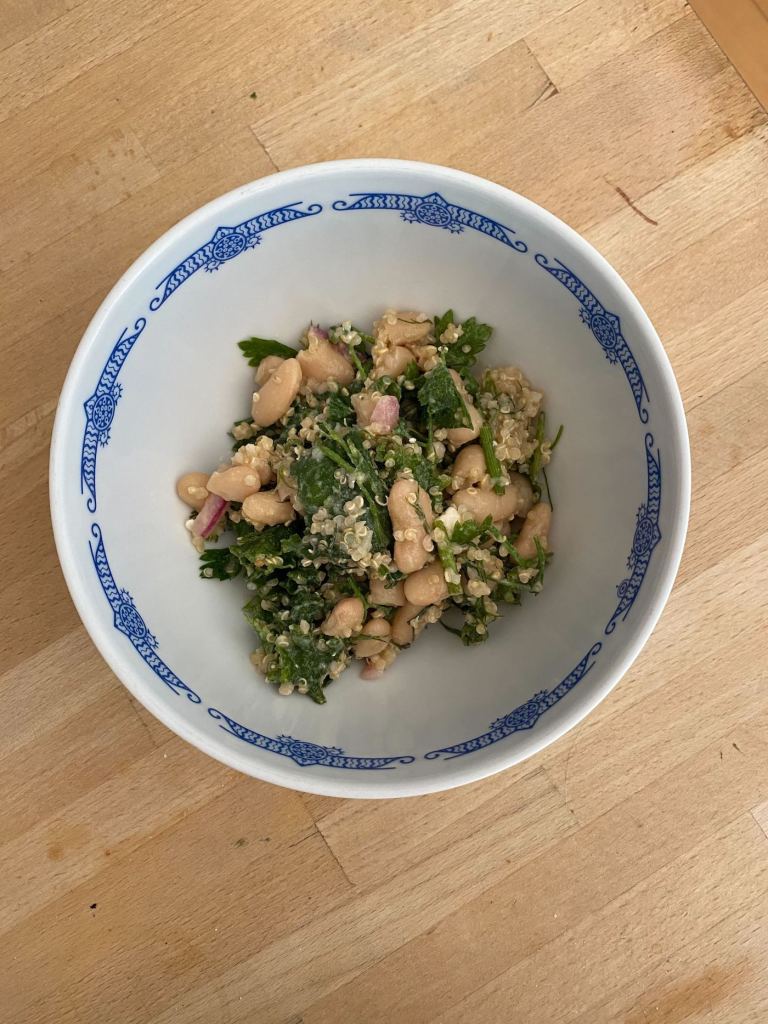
150, 203, 323, 310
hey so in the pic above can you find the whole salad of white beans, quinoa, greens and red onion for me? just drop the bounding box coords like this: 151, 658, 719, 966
177, 309, 560, 703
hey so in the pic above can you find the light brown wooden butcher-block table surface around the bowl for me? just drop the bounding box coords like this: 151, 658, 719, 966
0, 0, 768, 1024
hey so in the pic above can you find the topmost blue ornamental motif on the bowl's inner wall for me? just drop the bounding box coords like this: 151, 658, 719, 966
333, 193, 528, 253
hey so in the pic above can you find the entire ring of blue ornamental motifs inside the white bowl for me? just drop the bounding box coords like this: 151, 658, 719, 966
75, 184, 662, 770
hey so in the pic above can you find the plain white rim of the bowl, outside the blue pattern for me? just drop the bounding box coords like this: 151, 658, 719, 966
49, 158, 691, 799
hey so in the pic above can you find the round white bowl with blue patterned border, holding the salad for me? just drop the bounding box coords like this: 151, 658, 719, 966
51, 160, 690, 797
